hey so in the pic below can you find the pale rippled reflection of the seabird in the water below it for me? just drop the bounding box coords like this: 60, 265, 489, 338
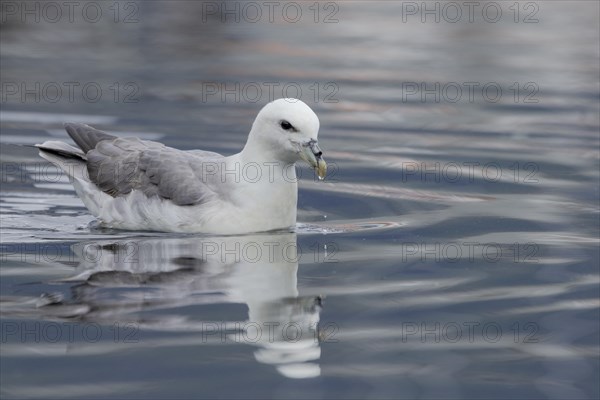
38, 232, 321, 378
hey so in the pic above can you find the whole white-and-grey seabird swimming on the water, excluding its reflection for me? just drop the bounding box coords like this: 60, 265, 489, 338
37, 99, 326, 234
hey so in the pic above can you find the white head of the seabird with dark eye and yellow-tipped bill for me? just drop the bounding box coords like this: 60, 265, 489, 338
246, 98, 327, 179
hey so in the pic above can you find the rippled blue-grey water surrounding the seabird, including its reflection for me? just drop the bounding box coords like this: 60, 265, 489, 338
0, 1, 600, 399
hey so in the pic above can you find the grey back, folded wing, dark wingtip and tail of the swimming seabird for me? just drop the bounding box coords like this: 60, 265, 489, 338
38, 123, 223, 206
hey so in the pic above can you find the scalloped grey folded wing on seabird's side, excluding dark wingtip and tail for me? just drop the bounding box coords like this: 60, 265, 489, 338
87, 138, 223, 206
